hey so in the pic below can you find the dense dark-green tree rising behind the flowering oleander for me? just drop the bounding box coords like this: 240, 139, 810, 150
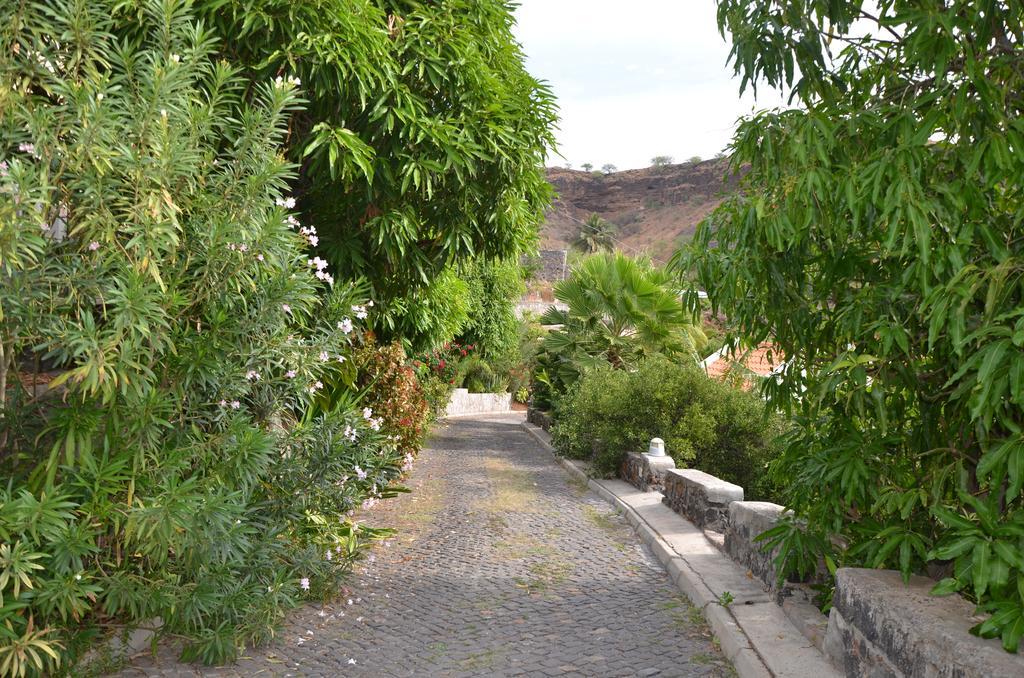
179, 0, 555, 339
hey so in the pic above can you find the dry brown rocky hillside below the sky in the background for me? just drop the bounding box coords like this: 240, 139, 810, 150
541, 159, 735, 261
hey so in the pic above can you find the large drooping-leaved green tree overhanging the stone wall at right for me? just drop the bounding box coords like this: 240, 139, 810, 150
690, 0, 1024, 651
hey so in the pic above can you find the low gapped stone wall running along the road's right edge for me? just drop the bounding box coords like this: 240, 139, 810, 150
606, 454, 1024, 678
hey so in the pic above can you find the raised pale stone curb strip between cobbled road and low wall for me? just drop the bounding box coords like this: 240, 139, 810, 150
520, 422, 841, 678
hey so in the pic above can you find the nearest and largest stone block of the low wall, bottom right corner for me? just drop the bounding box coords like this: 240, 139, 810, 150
825, 567, 1024, 678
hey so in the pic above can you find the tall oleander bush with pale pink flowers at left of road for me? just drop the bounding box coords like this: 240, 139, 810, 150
0, 0, 406, 675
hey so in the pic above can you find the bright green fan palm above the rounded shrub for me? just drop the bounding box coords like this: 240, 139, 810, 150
541, 253, 707, 393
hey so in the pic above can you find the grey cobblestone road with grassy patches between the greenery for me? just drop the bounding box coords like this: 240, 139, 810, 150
116, 416, 733, 677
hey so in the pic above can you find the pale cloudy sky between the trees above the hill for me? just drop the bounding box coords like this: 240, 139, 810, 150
515, 0, 783, 169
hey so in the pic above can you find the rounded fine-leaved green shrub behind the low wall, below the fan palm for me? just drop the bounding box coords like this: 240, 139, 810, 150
552, 356, 781, 499
